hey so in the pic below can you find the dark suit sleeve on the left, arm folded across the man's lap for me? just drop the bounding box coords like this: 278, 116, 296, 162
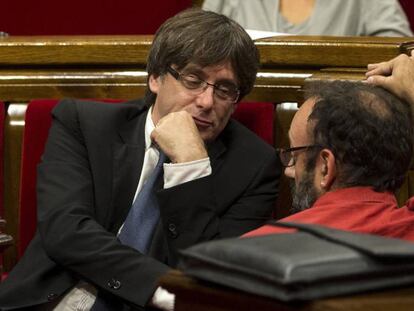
38, 101, 169, 307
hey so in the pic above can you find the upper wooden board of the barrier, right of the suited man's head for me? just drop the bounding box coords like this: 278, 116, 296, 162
256, 36, 413, 68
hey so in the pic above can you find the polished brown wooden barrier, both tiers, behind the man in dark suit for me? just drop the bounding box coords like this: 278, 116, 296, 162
0, 35, 412, 102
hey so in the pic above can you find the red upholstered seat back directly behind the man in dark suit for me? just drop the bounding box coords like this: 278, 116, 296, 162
17, 99, 274, 258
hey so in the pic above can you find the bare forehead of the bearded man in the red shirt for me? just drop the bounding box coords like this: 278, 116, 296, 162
289, 98, 315, 147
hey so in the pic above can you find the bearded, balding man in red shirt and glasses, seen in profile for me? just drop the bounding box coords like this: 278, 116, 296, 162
246, 81, 414, 240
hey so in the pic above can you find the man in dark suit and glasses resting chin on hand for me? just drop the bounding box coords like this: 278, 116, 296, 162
0, 10, 280, 310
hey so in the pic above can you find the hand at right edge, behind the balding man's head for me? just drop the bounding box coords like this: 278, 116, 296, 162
365, 50, 414, 108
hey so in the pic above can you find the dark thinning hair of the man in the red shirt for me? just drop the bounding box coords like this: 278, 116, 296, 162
306, 81, 413, 191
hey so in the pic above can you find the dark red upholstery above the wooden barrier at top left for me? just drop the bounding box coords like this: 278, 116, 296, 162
0, 0, 191, 35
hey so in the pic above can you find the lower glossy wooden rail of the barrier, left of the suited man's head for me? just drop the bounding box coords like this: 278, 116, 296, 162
0, 69, 147, 102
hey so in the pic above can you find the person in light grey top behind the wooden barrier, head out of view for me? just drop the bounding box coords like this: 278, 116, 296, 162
202, 0, 413, 37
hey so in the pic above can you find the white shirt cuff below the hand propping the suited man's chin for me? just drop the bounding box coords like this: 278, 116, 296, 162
164, 158, 211, 189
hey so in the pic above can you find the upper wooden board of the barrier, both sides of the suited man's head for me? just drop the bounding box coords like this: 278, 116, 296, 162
0, 35, 413, 68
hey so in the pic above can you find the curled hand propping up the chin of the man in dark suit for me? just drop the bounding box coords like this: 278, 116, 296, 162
151, 111, 208, 163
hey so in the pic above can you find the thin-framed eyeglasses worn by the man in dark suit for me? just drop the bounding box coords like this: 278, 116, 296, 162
167, 67, 240, 104
